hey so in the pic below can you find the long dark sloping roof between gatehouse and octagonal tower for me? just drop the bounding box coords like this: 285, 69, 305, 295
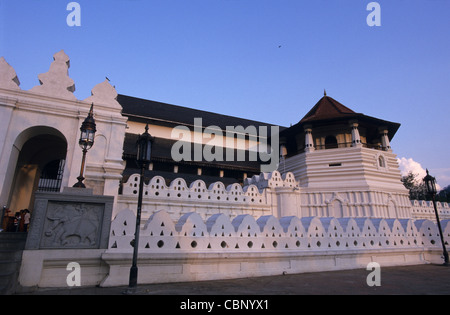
117, 94, 285, 130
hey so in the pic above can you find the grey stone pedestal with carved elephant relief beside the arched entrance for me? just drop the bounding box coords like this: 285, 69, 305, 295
25, 187, 114, 250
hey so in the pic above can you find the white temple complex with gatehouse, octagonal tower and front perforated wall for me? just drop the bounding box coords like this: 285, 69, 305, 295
0, 50, 450, 287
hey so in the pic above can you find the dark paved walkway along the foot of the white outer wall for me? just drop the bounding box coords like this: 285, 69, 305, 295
15, 265, 450, 300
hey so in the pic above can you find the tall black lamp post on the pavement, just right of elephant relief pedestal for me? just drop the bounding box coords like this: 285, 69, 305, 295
124, 124, 153, 294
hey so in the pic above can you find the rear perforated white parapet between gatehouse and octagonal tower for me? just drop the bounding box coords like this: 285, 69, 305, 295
116, 171, 298, 221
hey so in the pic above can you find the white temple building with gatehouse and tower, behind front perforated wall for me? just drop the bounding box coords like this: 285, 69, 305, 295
0, 51, 448, 219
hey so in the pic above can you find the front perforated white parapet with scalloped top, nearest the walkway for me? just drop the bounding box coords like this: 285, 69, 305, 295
108, 210, 450, 252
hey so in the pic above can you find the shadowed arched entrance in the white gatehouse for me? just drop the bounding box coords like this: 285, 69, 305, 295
8, 126, 67, 213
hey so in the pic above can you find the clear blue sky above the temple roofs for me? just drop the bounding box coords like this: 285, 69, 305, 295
0, 0, 450, 187
